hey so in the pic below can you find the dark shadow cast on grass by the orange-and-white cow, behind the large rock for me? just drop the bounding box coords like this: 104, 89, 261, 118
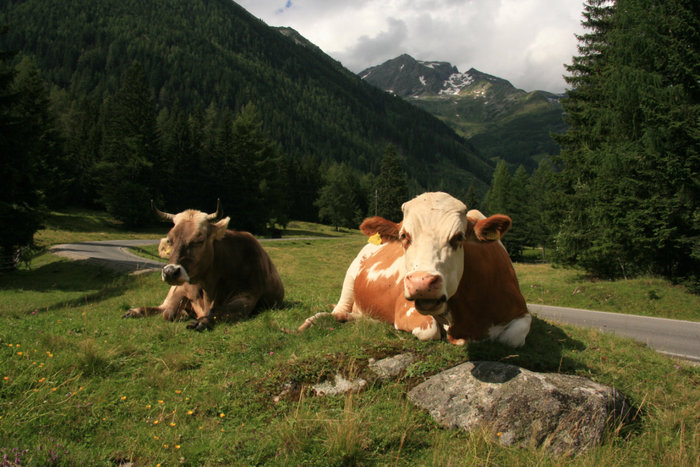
467, 316, 586, 373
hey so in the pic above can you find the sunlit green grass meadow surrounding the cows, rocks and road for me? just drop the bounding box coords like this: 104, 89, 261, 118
0, 212, 700, 466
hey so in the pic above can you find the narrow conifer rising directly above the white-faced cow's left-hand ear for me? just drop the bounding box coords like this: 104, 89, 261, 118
376, 144, 408, 222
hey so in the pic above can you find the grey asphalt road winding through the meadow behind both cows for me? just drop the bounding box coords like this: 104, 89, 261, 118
51, 238, 700, 362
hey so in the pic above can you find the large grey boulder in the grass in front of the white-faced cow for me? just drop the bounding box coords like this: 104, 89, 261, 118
408, 362, 630, 455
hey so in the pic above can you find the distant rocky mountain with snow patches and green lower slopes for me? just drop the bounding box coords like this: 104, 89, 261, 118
358, 54, 566, 170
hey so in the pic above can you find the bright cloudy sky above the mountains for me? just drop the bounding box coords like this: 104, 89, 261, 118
235, 0, 583, 92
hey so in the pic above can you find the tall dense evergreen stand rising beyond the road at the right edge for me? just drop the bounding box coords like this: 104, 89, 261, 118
557, 0, 700, 286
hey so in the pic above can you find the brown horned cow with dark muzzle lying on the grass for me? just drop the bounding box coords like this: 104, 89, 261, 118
124, 203, 284, 330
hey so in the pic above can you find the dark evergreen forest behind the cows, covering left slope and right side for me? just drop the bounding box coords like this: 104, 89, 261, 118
0, 0, 700, 290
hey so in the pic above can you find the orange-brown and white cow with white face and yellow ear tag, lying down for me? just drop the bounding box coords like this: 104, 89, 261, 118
300, 193, 531, 347
